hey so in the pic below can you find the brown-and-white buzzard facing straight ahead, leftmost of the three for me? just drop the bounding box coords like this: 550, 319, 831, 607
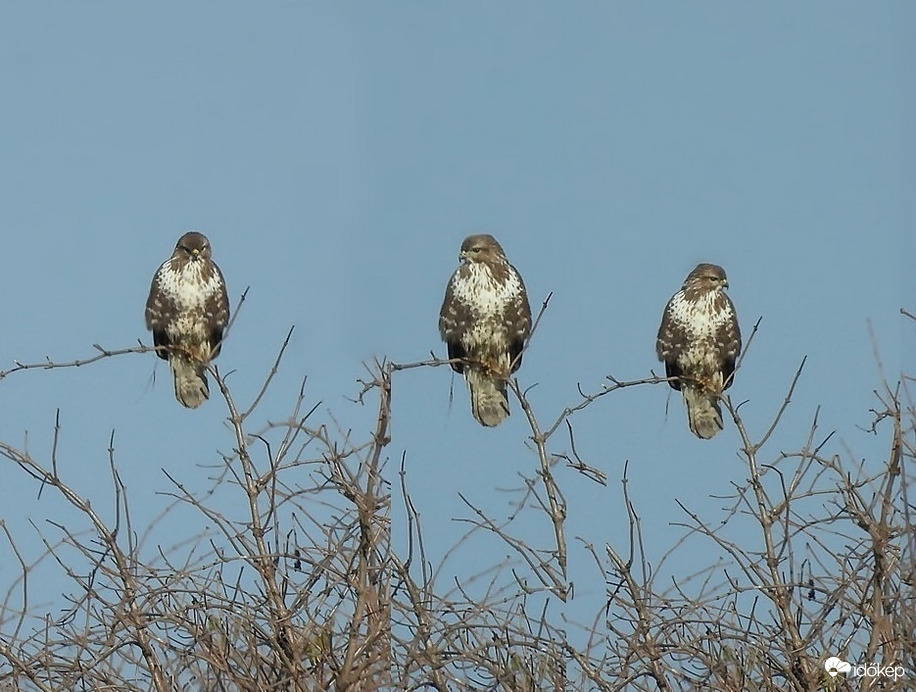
146, 231, 229, 408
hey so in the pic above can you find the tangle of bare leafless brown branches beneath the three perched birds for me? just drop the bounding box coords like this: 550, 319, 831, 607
0, 314, 916, 692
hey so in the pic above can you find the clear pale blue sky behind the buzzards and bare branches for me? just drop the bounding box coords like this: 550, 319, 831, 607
0, 2, 916, 652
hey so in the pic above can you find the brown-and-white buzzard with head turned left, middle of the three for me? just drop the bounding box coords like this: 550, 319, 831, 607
439, 235, 531, 427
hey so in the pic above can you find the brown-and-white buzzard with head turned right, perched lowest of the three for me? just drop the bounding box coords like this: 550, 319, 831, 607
655, 264, 741, 440
